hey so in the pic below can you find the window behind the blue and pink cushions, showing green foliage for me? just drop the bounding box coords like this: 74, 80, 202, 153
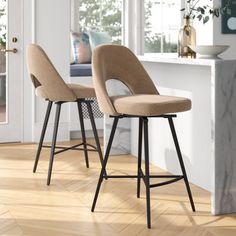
76, 0, 123, 44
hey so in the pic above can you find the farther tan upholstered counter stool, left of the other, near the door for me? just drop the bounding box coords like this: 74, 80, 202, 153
27, 44, 102, 185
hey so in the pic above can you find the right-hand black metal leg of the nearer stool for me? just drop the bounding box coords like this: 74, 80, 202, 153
168, 117, 196, 211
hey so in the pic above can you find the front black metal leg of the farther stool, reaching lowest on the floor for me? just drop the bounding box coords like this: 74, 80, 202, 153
47, 102, 62, 185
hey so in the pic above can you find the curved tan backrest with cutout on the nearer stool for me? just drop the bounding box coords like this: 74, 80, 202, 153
92, 45, 159, 115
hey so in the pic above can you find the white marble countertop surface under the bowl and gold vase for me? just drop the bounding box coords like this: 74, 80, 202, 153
137, 54, 236, 66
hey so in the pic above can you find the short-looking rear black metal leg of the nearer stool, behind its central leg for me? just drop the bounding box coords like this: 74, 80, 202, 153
137, 118, 143, 198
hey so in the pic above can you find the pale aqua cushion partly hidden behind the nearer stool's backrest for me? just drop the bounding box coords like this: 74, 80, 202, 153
89, 31, 112, 51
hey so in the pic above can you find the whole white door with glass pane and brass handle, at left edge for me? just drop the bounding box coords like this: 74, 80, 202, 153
0, 0, 23, 143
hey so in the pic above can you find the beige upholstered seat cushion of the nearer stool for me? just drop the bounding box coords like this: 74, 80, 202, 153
111, 94, 191, 116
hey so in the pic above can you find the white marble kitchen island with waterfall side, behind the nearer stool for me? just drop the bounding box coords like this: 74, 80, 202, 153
105, 56, 236, 214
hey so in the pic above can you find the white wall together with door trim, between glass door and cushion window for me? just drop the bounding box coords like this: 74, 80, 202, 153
24, 0, 70, 141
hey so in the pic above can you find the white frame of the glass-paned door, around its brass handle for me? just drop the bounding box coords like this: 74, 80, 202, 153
0, 0, 24, 142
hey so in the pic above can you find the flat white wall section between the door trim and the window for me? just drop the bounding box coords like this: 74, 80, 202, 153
35, 0, 70, 139
